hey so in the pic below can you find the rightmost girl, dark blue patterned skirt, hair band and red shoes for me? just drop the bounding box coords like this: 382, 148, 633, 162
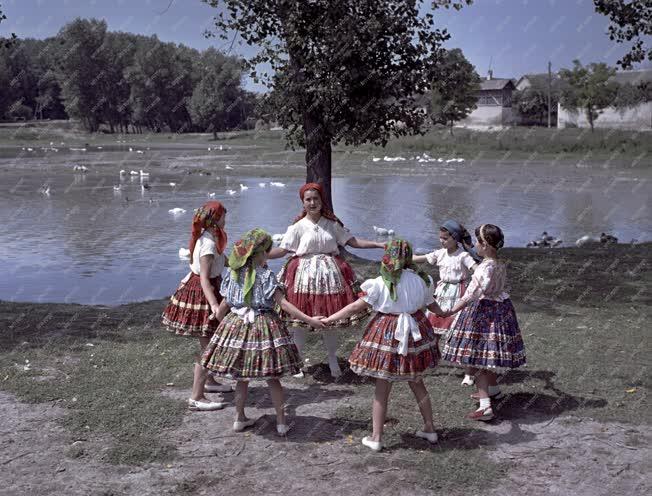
442, 224, 525, 420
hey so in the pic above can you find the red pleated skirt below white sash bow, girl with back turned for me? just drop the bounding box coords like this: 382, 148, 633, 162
349, 310, 439, 381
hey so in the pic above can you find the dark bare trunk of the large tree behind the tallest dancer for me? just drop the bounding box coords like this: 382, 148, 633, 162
303, 114, 333, 211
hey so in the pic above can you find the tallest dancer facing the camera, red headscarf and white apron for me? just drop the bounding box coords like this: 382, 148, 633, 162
269, 183, 383, 377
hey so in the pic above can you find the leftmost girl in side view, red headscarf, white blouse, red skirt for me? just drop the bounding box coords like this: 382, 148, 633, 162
162, 201, 232, 410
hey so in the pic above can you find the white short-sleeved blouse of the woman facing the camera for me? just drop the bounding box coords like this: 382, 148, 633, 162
279, 217, 353, 256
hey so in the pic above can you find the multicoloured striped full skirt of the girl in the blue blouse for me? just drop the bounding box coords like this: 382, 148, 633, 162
201, 312, 301, 380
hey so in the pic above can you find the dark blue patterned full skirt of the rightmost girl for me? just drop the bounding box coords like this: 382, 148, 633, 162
442, 299, 525, 369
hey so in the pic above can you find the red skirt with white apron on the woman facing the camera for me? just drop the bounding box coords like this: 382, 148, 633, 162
278, 254, 370, 327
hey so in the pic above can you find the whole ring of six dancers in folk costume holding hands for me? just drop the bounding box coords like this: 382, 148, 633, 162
162, 183, 525, 451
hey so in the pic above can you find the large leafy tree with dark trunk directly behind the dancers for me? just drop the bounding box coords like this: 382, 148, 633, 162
204, 0, 471, 205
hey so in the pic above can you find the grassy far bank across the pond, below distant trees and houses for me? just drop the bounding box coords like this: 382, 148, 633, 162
0, 121, 652, 166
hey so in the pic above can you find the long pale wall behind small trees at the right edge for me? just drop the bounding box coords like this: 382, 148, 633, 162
557, 102, 652, 130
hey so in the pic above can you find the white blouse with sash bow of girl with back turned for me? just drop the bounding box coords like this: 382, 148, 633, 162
360, 269, 435, 356
